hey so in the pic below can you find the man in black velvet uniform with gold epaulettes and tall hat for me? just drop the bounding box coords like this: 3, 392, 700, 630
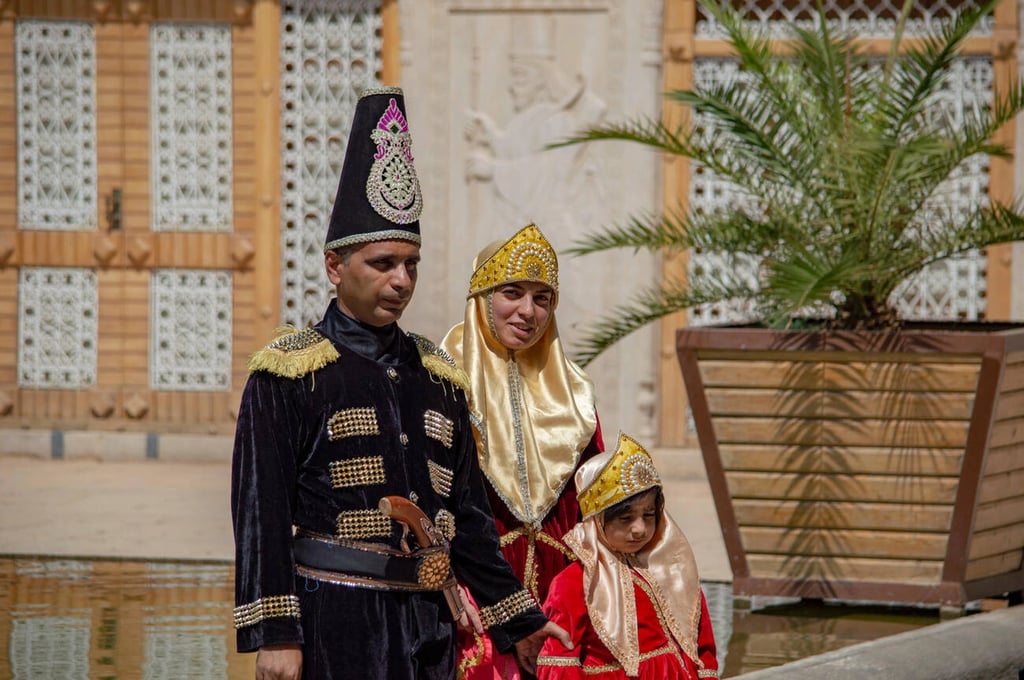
231, 88, 568, 680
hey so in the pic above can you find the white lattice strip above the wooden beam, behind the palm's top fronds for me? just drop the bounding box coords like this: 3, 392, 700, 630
696, 0, 993, 38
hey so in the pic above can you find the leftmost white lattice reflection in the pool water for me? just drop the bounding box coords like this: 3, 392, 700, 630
8, 610, 91, 680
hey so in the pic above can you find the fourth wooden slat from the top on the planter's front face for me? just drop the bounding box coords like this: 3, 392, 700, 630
719, 444, 963, 476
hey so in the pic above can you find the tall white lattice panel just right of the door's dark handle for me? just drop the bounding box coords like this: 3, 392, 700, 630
150, 23, 232, 231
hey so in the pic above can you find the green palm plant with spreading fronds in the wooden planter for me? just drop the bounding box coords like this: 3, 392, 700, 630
563, 0, 1024, 364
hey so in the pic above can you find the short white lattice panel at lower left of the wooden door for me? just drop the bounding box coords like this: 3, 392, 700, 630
17, 267, 98, 389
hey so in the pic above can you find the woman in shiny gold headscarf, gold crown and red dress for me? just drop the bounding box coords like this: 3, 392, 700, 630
441, 224, 603, 680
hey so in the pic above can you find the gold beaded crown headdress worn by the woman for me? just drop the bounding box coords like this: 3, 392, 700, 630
469, 224, 558, 297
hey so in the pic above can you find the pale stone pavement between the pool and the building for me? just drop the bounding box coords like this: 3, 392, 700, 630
0, 450, 732, 581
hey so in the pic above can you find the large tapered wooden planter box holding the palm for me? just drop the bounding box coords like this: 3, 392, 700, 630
677, 324, 1024, 607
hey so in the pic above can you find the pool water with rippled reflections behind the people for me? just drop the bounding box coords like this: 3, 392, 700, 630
0, 557, 938, 680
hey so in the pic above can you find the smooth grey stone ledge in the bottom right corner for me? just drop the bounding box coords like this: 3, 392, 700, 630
736, 605, 1024, 680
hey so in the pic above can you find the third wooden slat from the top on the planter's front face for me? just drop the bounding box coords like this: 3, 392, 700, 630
715, 417, 968, 449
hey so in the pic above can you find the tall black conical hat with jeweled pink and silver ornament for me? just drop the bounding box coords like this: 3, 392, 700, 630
324, 87, 423, 252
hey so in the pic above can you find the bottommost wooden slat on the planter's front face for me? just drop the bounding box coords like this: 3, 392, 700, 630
746, 554, 942, 585
